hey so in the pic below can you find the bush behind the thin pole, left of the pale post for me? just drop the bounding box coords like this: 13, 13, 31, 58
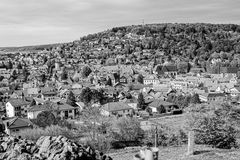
144, 125, 187, 146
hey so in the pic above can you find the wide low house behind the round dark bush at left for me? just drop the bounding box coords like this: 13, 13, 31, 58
27, 102, 78, 119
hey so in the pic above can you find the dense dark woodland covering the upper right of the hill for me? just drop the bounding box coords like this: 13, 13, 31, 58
81, 24, 240, 60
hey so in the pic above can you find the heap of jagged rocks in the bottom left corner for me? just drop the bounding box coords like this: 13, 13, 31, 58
0, 136, 111, 160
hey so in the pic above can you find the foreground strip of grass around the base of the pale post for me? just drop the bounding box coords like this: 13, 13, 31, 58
109, 145, 240, 160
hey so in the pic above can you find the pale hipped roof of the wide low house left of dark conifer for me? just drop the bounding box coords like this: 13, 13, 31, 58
102, 102, 132, 112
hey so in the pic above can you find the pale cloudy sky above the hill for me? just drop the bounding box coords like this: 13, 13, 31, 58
0, 0, 240, 47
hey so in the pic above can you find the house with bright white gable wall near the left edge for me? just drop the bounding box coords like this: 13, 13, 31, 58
6, 99, 30, 117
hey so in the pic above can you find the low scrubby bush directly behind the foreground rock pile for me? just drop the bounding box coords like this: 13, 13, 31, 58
15, 125, 74, 141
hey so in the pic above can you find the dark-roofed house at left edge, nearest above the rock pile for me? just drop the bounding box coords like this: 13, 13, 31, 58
3, 117, 33, 135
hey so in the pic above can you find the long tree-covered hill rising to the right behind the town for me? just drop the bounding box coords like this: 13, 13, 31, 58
1, 23, 240, 68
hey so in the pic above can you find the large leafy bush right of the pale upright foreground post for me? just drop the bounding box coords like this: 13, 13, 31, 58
188, 104, 239, 149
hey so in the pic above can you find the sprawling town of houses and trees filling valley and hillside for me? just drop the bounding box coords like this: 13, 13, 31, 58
0, 24, 240, 159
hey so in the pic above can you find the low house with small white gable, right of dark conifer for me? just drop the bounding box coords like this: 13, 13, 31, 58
148, 99, 179, 113
